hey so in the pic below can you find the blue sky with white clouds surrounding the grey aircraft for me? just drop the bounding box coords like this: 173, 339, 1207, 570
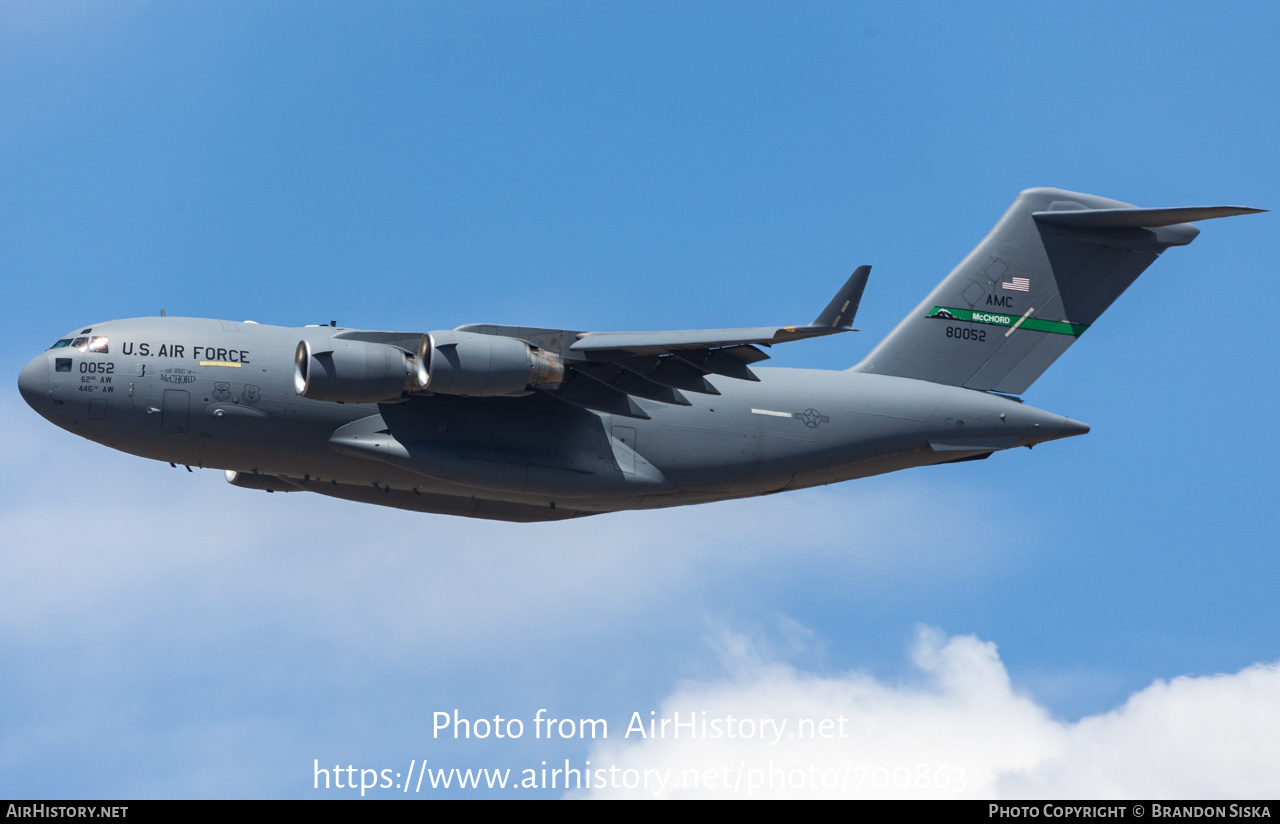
0, 3, 1280, 797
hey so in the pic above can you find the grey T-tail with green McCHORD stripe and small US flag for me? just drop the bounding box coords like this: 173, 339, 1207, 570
852, 188, 1266, 395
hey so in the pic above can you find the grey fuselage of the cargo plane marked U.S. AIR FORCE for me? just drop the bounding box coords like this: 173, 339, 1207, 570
19, 317, 1088, 521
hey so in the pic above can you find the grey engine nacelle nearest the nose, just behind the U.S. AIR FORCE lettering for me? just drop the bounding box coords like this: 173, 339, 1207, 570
293, 338, 413, 403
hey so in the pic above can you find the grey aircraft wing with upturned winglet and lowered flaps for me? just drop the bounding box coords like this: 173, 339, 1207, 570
454, 266, 872, 418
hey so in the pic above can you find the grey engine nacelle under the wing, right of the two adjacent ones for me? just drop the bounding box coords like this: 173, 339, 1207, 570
417, 331, 564, 397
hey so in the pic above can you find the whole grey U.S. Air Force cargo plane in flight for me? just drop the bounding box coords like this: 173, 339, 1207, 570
18, 188, 1262, 522
